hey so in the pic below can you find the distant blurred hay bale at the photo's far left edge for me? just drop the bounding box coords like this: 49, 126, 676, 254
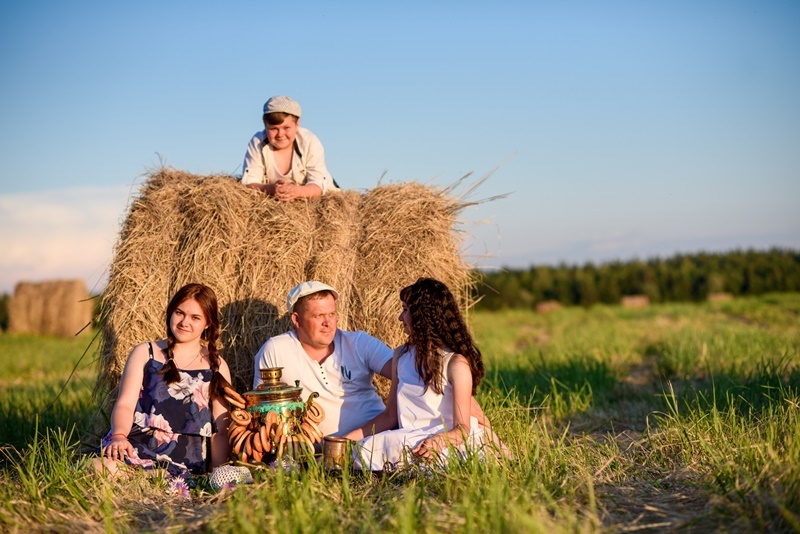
8, 280, 94, 337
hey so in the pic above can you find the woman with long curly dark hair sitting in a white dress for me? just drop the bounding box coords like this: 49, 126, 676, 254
347, 278, 499, 471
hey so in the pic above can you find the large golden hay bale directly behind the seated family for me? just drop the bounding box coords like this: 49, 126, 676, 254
98, 169, 478, 407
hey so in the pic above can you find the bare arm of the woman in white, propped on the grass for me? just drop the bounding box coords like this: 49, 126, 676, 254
412, 354, 472, 458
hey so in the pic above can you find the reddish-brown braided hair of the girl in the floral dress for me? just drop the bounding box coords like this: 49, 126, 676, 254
159, 283, 230, 399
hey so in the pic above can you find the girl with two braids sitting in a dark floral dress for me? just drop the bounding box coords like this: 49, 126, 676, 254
98, 284, 230, 475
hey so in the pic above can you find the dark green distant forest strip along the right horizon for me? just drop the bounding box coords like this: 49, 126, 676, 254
476, 248, 800, 310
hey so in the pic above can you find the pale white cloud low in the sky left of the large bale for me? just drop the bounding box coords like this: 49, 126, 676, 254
0, 186, 131, 293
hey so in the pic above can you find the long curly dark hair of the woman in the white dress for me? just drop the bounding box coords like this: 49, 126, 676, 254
400, 278, 484, 395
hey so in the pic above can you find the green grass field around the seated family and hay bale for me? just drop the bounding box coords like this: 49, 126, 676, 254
0, 294, 800, 533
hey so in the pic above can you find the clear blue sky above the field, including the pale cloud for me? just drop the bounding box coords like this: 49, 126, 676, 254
0, 0, 800, 291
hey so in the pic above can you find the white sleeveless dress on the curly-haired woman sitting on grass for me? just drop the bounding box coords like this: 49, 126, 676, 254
353, 347, 483, 471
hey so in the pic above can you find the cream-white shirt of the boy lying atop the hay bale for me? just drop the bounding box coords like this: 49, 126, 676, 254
242, 128, 336, 195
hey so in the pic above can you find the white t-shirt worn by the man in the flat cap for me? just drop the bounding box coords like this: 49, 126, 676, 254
253, 330, 392, 436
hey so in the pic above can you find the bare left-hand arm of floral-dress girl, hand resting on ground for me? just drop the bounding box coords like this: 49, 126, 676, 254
103, 343, 150, 460
